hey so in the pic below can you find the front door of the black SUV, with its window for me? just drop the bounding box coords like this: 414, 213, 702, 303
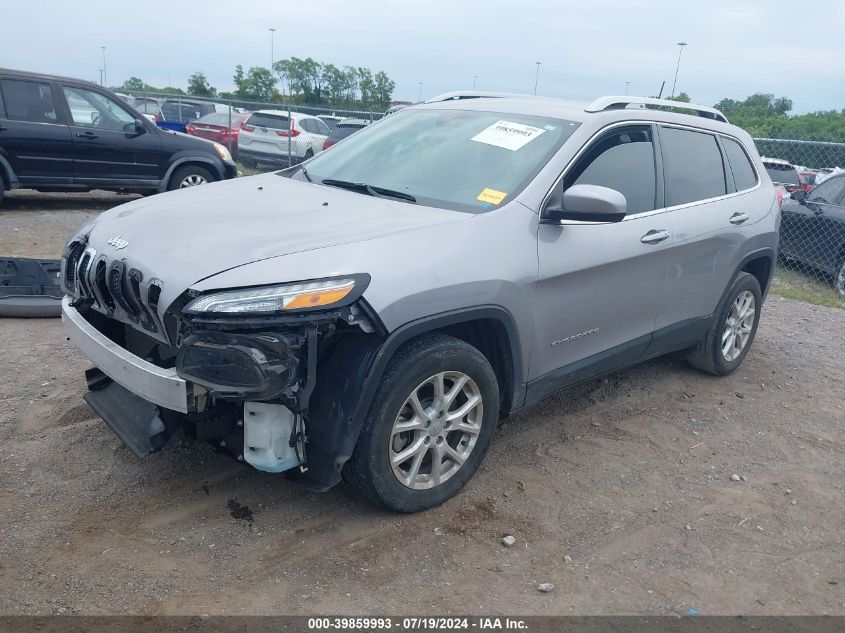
62, 85, 164, 187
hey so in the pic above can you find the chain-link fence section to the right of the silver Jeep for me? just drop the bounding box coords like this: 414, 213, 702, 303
754, 138, 845, 307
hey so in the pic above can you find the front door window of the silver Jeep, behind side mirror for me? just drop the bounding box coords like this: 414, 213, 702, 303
564, 125, 657, 213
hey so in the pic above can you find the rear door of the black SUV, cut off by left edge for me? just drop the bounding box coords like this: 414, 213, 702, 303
0, 77, 73, 186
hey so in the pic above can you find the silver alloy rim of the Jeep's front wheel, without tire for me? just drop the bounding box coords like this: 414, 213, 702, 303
388, 371, 484, 490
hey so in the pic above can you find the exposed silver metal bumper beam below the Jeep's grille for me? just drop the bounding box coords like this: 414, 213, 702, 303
62, 297, 188, 413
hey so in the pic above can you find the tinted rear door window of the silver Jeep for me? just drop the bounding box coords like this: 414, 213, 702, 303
660, 127, 727, 207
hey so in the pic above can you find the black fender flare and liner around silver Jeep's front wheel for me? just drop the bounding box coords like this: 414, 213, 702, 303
306, 305, 525, 490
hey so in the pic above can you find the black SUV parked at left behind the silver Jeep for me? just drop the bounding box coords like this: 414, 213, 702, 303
0, 68, 237, 198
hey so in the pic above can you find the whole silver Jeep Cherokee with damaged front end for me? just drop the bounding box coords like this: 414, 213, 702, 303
63, 93, 780, 512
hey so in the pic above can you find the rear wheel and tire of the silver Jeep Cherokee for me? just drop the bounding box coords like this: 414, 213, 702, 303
687, 272, 763, 376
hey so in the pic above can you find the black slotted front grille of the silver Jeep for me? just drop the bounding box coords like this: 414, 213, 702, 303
64, 242, 164, 334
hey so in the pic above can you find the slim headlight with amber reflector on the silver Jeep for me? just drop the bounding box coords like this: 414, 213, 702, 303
185, 278, 358, 314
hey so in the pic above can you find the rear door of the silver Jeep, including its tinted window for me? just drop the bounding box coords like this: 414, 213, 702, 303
656, 125, 752, 334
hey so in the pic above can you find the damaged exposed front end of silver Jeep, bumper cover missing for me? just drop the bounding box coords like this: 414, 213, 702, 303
63, 230, 386, 488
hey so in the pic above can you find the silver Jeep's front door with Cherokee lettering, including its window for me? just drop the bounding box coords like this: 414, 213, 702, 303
528, 124, 673, 400
